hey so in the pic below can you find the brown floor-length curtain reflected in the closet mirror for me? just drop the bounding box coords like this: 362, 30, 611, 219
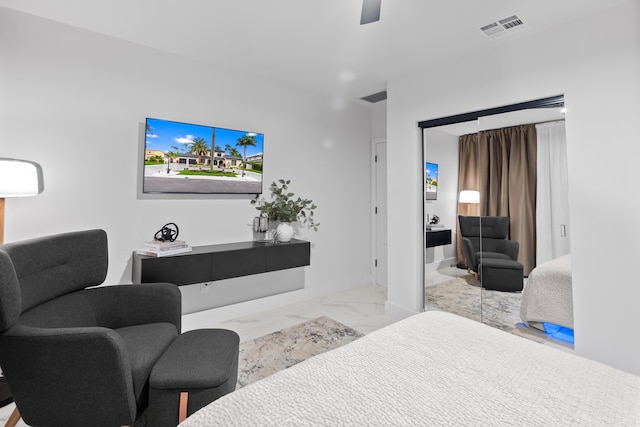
458, 125, 537, 275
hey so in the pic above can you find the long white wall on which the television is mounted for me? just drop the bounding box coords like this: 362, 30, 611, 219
0, 8, 371, 324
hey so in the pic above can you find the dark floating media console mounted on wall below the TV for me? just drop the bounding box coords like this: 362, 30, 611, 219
132, 239, 311, 286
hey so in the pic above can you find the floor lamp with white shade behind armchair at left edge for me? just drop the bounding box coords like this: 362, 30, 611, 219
0, 157, 44, 425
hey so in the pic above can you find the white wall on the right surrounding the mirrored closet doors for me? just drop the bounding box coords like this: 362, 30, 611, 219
387, 1, 640, 374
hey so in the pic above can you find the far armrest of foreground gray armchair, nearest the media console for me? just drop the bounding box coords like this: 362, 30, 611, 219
83, 283, 182, 333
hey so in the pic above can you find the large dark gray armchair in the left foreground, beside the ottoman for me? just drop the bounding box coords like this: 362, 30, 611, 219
0, 230, 181, 426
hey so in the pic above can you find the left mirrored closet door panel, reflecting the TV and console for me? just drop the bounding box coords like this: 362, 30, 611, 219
422, 119, 482, 321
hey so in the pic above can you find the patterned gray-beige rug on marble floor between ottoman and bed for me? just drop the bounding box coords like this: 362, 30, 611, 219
237, 316, 363, 388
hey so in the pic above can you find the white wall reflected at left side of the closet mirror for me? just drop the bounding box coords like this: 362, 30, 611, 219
424, 129, 459, 272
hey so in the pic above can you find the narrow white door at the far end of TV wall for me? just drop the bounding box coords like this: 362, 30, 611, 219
373, 140, 387, 287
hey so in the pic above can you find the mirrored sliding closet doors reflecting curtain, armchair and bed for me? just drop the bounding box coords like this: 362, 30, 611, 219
423, 98, 573, 347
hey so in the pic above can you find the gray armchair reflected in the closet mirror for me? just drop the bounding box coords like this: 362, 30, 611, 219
458, 215, 520, 275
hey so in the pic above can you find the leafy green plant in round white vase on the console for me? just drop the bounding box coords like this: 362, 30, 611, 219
251, 179, 320, 242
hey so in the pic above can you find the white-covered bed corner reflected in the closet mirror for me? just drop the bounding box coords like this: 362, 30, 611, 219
520, 255, 573, 329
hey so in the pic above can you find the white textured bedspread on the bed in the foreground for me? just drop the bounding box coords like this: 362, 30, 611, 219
176, 311, 640, 427
